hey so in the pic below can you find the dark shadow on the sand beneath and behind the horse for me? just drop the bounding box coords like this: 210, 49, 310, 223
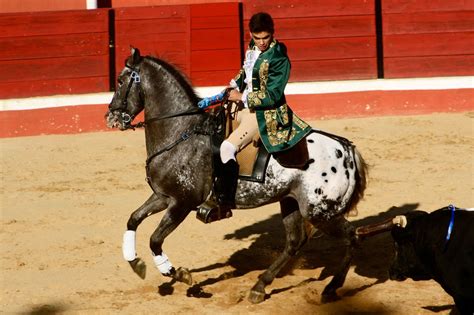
158, 204, 426, 298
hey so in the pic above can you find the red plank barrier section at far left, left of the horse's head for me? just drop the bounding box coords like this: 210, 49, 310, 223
0, 10, 109, 98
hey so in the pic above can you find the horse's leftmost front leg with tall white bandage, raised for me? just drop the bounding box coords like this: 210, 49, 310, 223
122, 194, 168, 279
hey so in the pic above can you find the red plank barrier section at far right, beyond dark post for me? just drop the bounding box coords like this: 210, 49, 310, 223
382, 0, 474, 78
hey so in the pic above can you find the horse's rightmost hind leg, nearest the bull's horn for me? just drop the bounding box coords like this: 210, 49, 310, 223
318, 216, 357, 303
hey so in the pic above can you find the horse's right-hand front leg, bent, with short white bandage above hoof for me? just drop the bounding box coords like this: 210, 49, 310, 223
150, 204, 193, 285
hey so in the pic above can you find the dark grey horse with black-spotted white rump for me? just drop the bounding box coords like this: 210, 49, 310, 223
105, 47, 367, 303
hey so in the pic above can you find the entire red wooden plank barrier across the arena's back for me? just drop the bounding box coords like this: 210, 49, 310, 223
0, 0, 474, 98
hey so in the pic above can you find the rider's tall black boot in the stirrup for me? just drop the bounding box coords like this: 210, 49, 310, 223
196, 160, 239, 223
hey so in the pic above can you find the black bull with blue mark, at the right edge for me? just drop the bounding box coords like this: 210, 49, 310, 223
357, 206, 474, 314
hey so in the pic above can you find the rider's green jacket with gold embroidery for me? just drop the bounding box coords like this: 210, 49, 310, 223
234, 40, 311, 153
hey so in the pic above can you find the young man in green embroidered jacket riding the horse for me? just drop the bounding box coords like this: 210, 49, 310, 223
198, 12, 311, 223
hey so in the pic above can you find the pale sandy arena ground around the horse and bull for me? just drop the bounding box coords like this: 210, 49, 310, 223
0, 112, 474, 315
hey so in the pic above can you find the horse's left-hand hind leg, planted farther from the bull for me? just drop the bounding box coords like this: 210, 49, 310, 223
249, 198, 308, 304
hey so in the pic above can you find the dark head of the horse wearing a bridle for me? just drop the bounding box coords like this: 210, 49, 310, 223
105, 47, 144, 130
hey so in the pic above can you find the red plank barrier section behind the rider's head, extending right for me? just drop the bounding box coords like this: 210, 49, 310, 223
243, 0, 377, 82
